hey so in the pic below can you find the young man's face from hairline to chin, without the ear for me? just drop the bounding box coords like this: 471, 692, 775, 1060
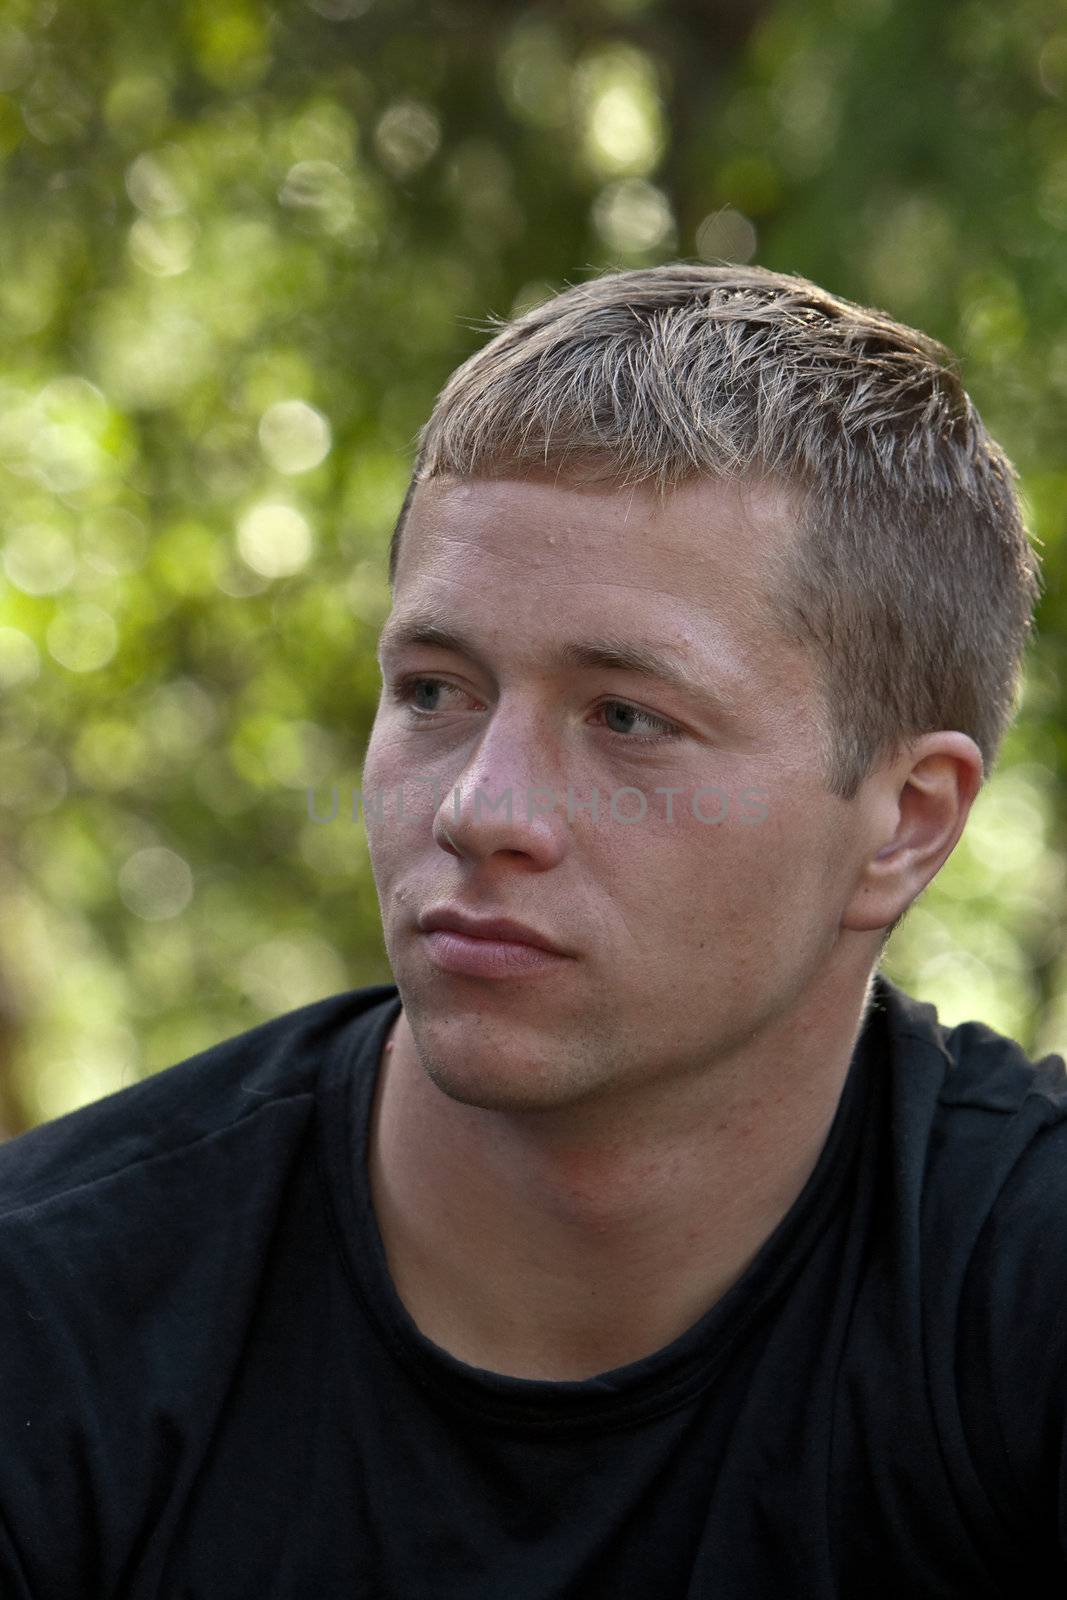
363, 477, 861, 1109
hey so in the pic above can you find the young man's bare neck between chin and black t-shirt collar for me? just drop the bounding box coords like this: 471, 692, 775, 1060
370, 953, 867, 1381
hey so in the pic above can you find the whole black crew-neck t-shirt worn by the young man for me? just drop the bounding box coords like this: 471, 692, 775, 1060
0, 976, 1067, 1600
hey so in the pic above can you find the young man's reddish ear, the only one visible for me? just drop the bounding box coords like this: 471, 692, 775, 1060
841, 733, 984, 933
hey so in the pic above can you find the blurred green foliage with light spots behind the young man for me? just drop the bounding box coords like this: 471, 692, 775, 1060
0, 0, 1067, 1136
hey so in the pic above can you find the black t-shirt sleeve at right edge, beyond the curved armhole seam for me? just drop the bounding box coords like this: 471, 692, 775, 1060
957, 1120, 1067, 1574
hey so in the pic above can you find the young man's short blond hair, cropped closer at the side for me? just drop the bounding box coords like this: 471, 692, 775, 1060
389, 262, 1040, 798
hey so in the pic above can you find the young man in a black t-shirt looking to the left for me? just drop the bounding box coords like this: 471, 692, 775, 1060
0, 266, 1067, 1600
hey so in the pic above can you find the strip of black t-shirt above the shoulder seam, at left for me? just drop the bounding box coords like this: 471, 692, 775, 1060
0, 984, 397, 1216
